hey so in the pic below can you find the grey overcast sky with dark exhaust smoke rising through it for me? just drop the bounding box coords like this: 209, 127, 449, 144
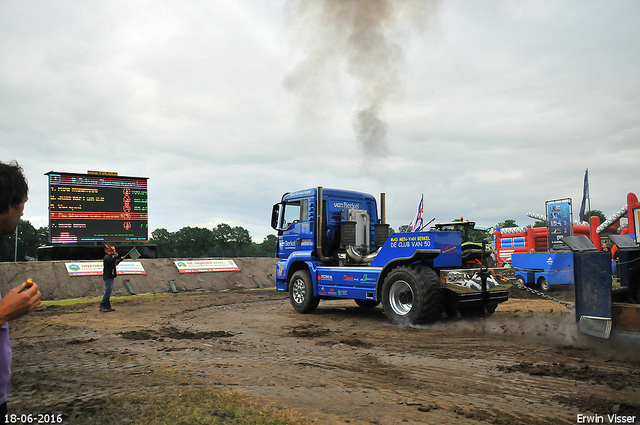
0, 0, 640, 240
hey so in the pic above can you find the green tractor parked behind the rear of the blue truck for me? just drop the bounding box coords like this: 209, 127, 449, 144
431, 219, 496, 267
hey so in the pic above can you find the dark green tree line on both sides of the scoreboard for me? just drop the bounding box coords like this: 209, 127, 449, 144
0, 220, 278, 262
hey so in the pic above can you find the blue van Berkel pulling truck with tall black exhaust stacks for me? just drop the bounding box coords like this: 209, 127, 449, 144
271, 187, 509, 325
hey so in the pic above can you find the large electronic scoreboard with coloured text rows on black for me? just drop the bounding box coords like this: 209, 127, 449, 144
45, 171, 149, 244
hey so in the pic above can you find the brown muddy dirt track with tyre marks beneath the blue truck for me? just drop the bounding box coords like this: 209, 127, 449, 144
9, 290, 640, 425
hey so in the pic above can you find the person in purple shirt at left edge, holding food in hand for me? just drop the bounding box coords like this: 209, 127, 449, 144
0, 162, 41, 421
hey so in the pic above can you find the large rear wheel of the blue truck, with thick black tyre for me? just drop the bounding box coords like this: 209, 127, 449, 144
382, 266, 443, 326
